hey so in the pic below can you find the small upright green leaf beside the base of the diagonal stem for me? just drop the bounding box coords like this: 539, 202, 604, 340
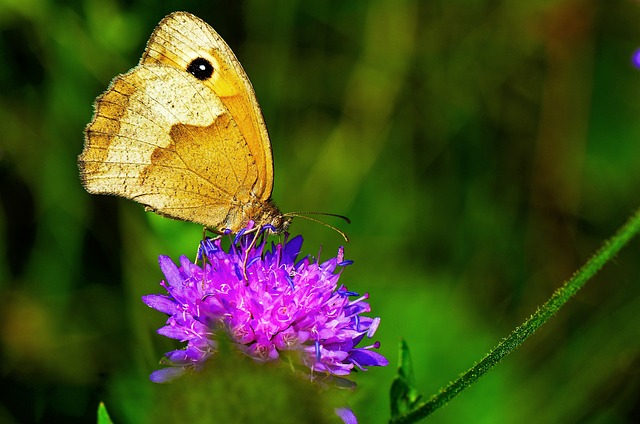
390, 339, 422, 418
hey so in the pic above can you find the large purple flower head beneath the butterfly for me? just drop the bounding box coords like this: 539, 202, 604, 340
142, 223, 388, 382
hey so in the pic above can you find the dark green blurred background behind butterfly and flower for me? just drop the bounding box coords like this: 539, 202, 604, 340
0, 0, 640, 423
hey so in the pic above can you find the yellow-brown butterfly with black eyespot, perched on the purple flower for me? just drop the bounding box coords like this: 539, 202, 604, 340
78, 12, 291, 233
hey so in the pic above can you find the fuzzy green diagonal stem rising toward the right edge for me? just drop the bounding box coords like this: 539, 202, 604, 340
390, 209, 640, 424
